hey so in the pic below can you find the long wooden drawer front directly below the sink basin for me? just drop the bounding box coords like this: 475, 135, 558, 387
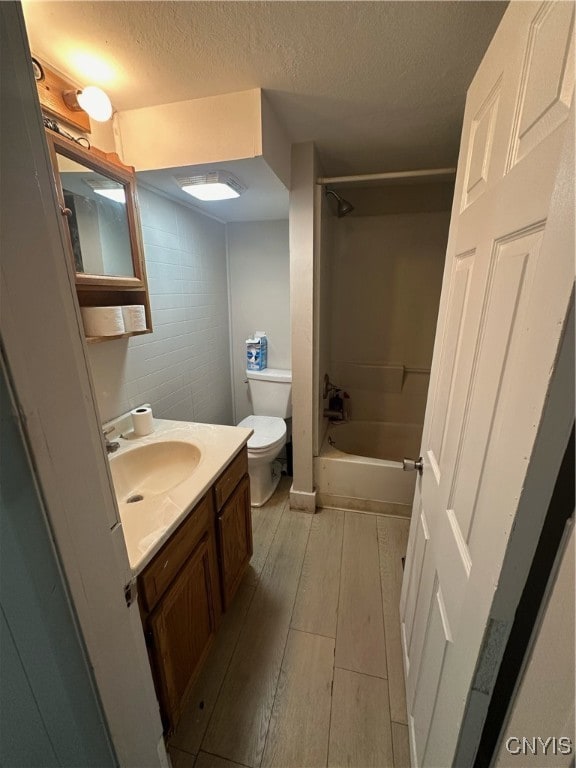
139, 493, 213, 611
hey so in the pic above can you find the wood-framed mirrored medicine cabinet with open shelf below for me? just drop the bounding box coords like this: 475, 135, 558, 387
46, 129, 152, 343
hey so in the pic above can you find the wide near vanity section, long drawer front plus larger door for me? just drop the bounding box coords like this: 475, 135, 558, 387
138, 492, 221, 733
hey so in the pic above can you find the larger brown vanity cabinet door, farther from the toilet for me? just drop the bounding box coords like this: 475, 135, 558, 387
148, 533, 218, 730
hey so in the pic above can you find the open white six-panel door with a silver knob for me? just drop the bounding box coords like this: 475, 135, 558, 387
400, 2, 574, 768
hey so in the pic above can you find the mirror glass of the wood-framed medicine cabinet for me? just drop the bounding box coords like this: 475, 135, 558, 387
57, 153, 134, 277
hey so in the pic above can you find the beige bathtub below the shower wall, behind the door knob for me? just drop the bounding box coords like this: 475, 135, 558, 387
314, 421, 422, 517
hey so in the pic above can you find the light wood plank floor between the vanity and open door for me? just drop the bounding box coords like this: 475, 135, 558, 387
169, 478, 410, 768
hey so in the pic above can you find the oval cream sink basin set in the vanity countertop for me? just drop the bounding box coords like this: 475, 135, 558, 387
110, 440, 202, 503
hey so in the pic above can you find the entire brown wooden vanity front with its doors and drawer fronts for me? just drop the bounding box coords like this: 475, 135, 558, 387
138, 447, 252, 734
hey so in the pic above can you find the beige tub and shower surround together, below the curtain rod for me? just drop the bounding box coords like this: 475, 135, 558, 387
314, 192, 452, 516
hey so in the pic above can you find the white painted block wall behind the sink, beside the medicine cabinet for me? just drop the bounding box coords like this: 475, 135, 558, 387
88, 187, 232, 424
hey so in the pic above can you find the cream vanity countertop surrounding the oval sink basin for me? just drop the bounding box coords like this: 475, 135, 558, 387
110, 419, 252, 575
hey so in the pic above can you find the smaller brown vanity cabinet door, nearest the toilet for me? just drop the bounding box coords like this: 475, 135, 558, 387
218, 475, 252, 610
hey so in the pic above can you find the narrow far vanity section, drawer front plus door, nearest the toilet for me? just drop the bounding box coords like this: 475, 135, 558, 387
214, 448, 253, 610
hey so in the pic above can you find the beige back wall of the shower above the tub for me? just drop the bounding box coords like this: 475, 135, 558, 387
330, 184, 452, 424
